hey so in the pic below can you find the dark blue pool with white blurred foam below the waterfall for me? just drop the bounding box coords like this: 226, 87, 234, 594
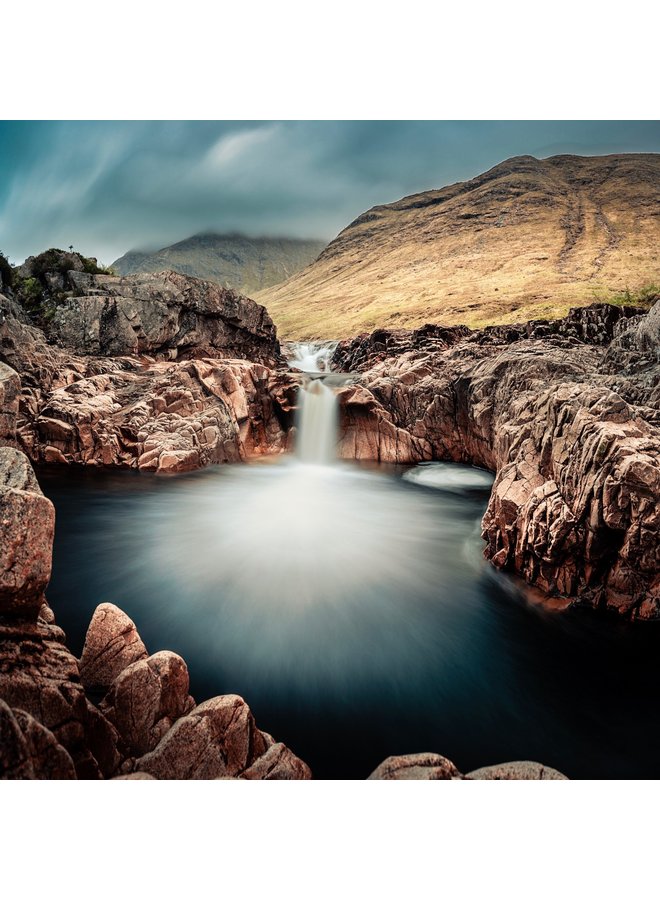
39, 463, 660, 778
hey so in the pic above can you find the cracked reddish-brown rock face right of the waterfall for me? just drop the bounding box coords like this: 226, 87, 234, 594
334, 303, 660, 619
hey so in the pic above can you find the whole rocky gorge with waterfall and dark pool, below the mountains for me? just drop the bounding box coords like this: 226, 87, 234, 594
0, 243, 660, 778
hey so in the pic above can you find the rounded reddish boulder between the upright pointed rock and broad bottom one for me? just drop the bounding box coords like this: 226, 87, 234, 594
102, 650, 195, 756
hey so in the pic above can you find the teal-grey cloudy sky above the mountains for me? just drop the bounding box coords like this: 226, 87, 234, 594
0, 121, 660, 265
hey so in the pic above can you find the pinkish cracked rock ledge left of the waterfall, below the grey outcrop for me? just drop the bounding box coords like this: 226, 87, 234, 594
0, 300, 287, 472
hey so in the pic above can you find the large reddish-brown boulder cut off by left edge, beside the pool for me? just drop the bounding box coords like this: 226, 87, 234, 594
0, 447, 55, 620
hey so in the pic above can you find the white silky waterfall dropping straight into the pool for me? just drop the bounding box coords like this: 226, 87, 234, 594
296, 378, 337, 466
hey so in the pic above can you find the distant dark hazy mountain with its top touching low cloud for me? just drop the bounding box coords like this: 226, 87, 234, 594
112, 233, 325, 295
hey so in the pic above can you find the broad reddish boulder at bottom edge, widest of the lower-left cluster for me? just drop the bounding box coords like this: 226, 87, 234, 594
135, 694, 276, 779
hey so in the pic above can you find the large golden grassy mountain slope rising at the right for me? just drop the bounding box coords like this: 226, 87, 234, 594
258, 153, 660, 339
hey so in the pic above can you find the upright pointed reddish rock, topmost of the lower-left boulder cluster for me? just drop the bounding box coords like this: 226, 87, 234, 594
80, 603, 148, 694
